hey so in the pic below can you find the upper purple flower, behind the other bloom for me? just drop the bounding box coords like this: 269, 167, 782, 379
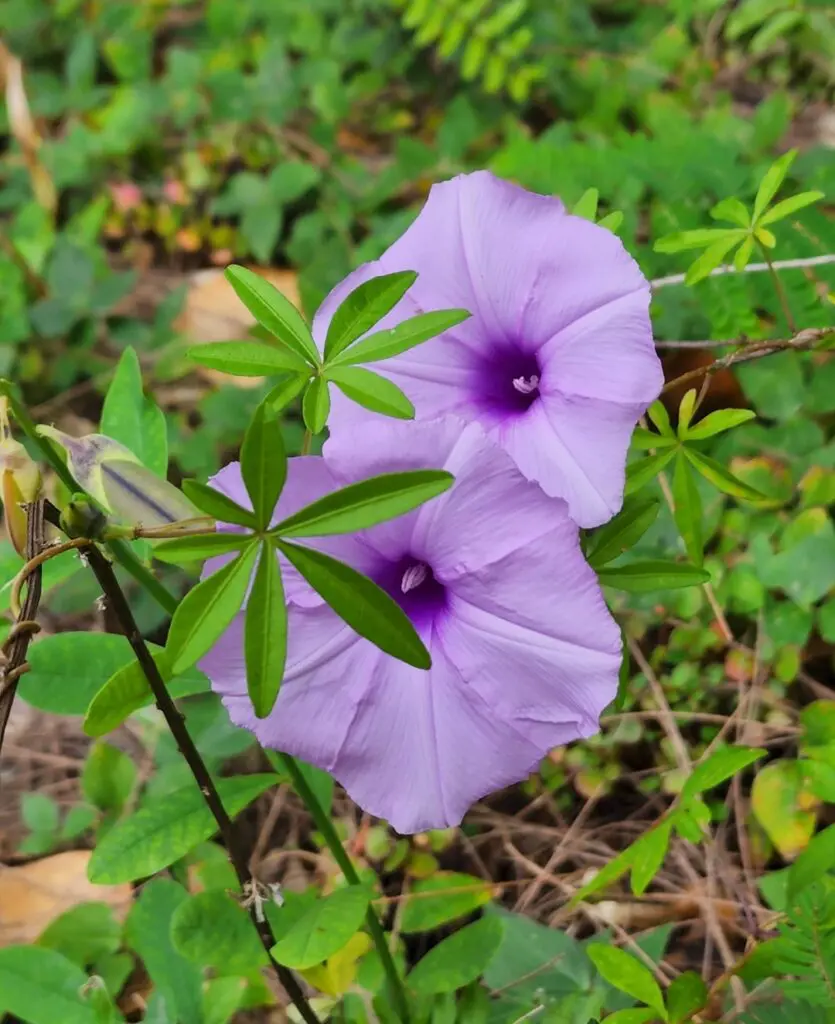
314, 171, 663, 526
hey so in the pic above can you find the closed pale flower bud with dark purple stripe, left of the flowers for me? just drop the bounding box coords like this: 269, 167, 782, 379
38, 427, 202, 527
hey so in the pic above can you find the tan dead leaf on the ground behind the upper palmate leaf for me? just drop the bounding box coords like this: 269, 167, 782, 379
174, 266, 301, 387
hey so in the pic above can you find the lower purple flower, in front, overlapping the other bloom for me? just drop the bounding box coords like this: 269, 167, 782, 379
201, 417, 621, 834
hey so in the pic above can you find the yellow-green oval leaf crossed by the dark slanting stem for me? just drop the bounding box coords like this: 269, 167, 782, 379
84, 644, 210, 737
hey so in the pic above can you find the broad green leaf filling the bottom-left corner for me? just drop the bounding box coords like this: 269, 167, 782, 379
0, 946, 98, 1024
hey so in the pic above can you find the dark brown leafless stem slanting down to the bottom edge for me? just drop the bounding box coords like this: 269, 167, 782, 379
52, 510, 320, 1024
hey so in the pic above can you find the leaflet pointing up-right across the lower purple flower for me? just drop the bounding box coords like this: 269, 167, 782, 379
274, 469, 455, 537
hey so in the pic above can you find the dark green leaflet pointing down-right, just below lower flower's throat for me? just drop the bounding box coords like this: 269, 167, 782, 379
277, 541, 431, 669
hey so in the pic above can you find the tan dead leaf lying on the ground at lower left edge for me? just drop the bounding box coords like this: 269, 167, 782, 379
0, 850, 133, 946
